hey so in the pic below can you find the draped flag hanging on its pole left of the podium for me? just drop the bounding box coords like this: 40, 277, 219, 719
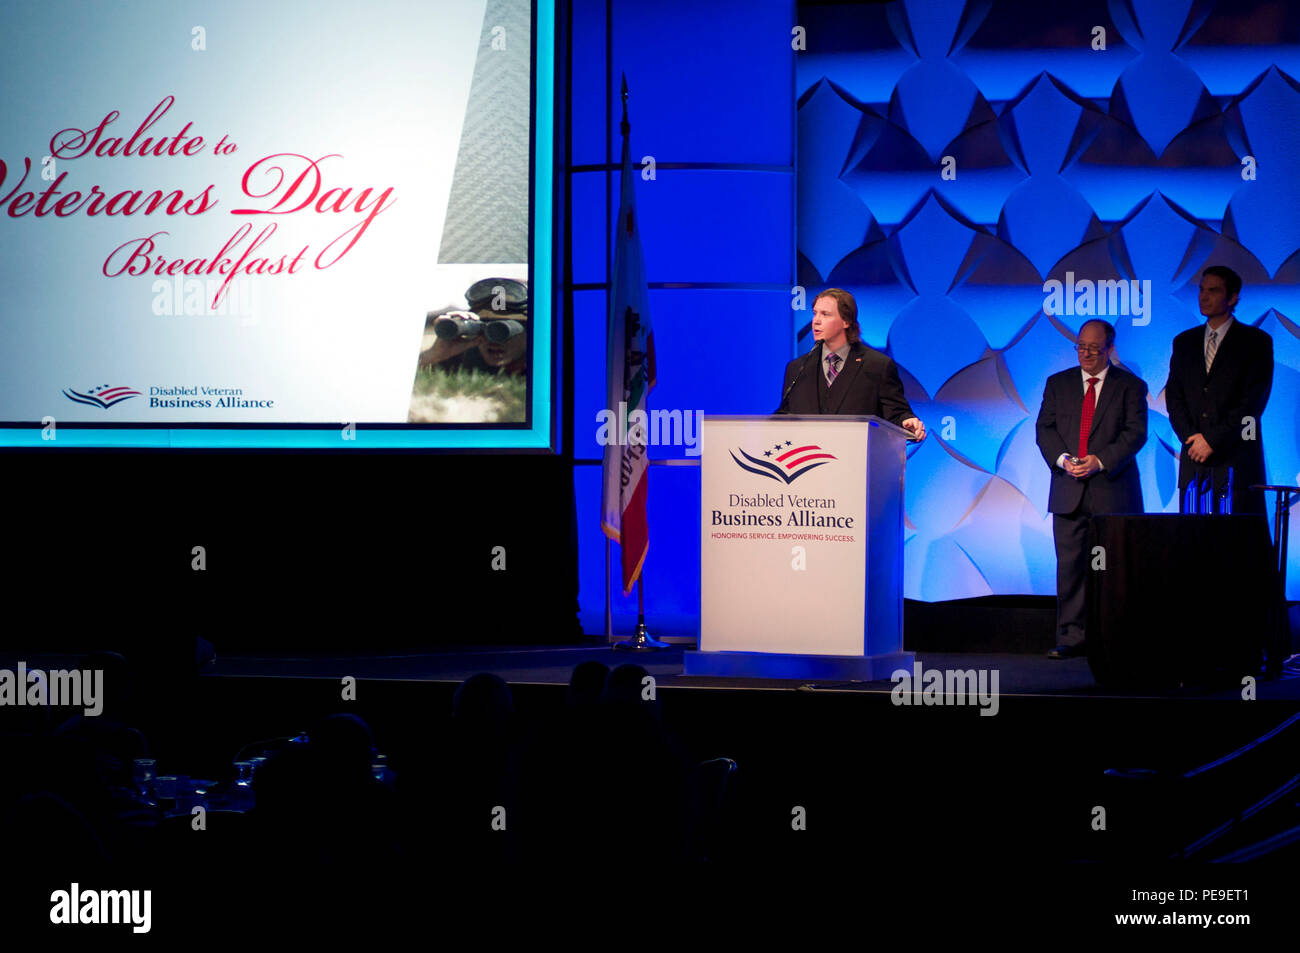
601, 77, 655, 595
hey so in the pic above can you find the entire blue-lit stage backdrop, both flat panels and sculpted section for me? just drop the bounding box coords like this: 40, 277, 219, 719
569, 0, 1300, 634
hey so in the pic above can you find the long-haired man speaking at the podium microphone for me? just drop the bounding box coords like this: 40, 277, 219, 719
776, 287, 926, 441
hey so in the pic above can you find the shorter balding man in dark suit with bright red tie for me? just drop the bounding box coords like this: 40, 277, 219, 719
1037, 320, 1147, 658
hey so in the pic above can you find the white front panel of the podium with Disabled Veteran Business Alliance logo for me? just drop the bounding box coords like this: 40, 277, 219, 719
699, 416, 873, 655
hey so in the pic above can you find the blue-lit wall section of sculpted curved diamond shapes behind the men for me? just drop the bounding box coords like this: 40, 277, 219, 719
794, 0, 1300, 601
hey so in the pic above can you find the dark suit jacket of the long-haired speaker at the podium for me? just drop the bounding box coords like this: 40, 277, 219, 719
775, 341, 917, 424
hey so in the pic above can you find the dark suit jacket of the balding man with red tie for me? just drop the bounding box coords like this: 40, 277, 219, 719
1037, 364, 1147, 515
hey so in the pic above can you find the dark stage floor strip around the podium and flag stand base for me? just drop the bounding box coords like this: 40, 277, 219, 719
189, 645, 1300, 701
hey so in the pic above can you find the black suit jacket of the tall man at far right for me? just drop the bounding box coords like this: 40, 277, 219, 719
1165, 320, 1273, 489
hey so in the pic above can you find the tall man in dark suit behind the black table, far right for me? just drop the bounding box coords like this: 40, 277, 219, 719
1165, 265, 1273, 514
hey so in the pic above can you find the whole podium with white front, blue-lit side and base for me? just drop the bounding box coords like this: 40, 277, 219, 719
684, 415, 913, 680
